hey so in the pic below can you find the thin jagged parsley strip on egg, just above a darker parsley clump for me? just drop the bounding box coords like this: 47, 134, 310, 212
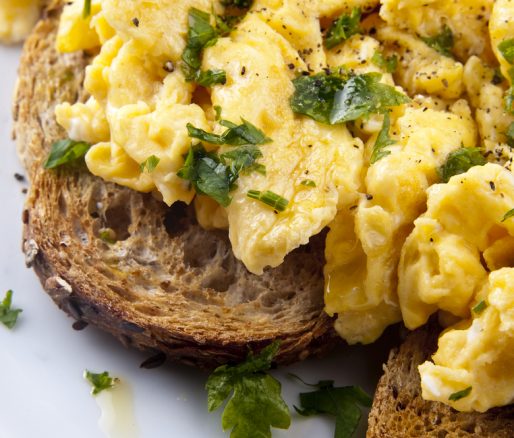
187, 119, 272, 146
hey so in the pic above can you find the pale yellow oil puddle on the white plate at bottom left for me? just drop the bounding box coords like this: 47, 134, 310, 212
95, 380, 139, 438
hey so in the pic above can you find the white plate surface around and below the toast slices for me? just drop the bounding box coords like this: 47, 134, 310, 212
0, 42, 396, 438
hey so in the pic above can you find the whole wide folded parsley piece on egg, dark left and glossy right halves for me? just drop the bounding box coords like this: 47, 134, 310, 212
291, 73, 410, 125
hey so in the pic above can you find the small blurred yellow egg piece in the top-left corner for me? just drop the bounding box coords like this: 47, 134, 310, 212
0, 0, 40, 43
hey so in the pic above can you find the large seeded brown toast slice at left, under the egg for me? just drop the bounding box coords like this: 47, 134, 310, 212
14, 1, 338, 367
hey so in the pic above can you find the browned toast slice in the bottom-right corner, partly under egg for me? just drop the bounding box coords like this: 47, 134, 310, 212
367, 324, 514, 438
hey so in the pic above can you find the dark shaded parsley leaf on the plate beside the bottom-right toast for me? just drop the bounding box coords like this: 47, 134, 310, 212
295, 380, 372, 438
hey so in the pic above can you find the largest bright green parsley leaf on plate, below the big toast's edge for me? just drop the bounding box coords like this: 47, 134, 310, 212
205, 341, 291, 438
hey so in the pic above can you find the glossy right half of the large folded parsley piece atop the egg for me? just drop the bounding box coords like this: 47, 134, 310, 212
330, 73, 410, 124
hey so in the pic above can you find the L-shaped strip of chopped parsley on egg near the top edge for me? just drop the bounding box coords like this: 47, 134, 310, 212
182, 8, 226, 87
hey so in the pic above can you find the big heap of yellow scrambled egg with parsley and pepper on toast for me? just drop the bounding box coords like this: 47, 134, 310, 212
55, 0, 514, 411
